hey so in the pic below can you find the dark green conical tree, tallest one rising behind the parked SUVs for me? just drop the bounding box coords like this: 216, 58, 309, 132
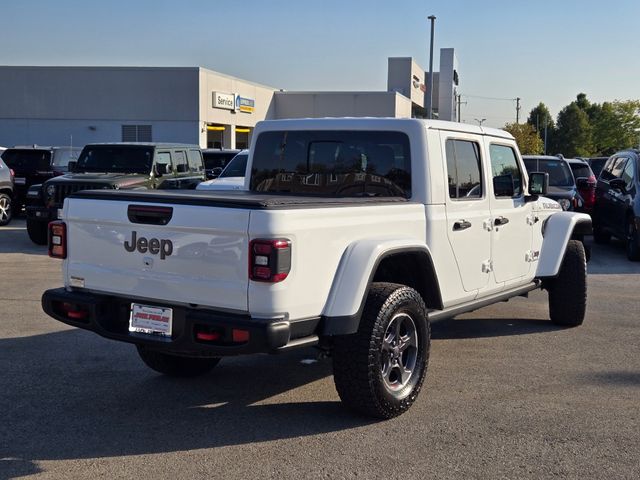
554, 102, 594, 157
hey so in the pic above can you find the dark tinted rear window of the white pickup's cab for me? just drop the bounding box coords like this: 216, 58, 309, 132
250, 130, 411, 198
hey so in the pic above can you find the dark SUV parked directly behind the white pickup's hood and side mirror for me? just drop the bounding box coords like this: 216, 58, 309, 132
522, 155, 584, 211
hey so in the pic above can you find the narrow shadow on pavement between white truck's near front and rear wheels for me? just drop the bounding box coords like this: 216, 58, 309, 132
431, 318, 563, 340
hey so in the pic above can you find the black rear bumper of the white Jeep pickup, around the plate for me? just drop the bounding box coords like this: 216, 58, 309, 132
42, 288, 319, 357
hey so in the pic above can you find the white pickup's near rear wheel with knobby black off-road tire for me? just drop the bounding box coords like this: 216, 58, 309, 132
333, 283, 431, 419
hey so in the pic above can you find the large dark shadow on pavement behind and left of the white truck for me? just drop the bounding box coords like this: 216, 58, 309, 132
0, 330, 371, 477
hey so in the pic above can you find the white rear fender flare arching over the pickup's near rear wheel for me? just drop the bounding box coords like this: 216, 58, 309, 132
319, 240, 443, 335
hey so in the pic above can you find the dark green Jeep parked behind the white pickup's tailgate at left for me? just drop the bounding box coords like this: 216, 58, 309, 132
27, 143, 204, 245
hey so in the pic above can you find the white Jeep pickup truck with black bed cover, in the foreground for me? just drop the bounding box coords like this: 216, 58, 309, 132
42, 118, 591, 418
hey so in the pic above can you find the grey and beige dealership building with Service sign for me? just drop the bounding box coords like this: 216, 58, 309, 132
0, 49, 458, 148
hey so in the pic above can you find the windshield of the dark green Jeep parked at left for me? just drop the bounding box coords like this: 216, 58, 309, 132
76, 145, 153, 174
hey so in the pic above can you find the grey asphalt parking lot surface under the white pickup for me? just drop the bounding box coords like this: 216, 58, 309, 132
0, 219, 640, 479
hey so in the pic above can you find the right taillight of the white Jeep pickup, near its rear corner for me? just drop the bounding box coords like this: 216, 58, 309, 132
249, 238, 291, 283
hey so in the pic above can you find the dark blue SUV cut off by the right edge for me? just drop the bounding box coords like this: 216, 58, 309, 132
593, 150, 640, 261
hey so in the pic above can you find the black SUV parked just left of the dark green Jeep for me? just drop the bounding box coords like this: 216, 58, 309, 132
2, 145, 81, 212
